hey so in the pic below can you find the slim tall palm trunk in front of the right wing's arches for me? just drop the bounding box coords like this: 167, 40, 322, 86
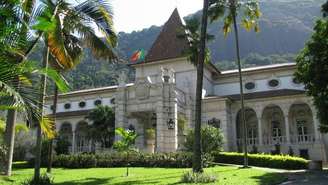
232, 8, 248, 168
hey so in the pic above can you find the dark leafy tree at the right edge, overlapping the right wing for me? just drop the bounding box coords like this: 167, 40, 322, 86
295, 2, 328, 133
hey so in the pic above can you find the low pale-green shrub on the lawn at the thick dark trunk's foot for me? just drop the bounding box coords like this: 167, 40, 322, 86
181, 171, 217, 183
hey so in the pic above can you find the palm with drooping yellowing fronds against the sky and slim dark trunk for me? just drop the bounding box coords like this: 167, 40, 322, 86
47, 0, 117, 173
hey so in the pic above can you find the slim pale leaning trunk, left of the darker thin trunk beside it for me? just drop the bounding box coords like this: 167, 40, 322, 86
34, 47, 49, 182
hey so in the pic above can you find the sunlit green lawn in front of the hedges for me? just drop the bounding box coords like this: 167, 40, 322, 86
0, 166, 285, 185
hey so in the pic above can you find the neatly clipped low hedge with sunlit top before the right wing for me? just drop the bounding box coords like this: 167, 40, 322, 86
212, 152, 309, 169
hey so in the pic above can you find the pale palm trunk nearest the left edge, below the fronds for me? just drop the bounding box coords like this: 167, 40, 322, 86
5, 110, 17, 176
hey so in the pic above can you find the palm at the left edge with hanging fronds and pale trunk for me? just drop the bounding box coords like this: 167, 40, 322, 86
0, 0, 67, 176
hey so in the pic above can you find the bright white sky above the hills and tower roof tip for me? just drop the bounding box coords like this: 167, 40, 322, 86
110, 0, 203, 33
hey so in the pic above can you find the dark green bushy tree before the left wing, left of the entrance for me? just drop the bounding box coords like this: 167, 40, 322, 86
86, 106, 115, 148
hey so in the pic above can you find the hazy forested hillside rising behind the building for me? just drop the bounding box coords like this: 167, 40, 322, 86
32, 0, 324, 90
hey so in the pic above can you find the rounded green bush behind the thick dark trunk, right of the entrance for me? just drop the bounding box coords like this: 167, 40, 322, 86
184, 126, 223, 153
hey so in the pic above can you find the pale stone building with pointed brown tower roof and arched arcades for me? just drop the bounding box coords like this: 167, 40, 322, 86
47, 10, 328, 160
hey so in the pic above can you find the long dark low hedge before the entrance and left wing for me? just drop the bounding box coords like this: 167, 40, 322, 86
29, 152, 212, 168
